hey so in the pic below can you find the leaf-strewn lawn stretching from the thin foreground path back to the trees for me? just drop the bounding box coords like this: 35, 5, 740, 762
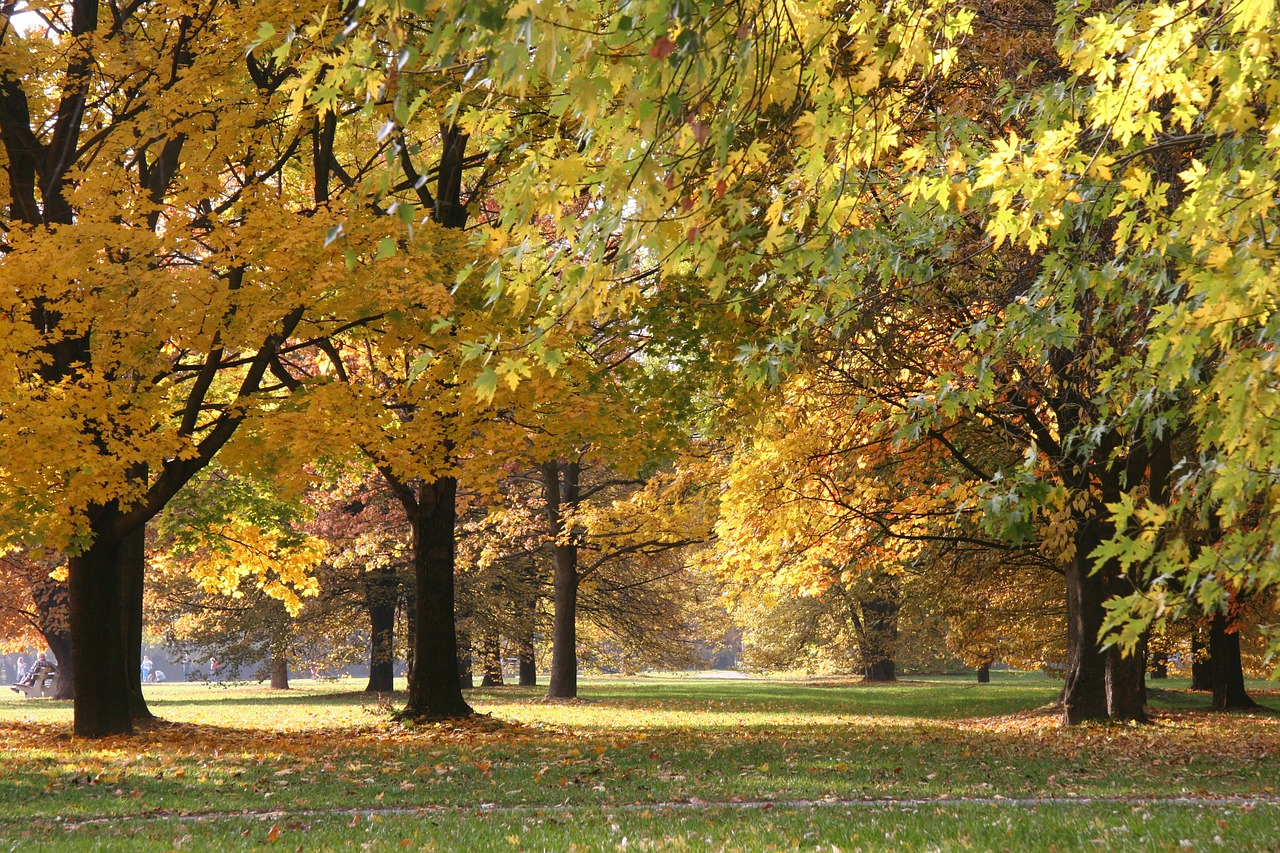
0, 684, 1280, 826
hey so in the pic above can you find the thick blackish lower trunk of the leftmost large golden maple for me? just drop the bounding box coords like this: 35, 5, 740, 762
68, 507, 138, 738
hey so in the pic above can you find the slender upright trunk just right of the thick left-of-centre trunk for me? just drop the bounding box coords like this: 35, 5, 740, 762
543, 462, 582, 699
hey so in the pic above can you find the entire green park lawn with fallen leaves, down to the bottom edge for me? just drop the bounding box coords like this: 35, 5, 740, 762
0, 672, 1280, 850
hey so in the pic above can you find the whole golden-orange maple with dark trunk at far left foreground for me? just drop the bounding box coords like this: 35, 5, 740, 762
0, 0, 460, 736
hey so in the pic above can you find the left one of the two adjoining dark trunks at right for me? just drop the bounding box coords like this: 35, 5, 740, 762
1062, 517, 1107, 725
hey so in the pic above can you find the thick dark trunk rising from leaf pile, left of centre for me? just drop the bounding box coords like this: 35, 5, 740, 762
402, 476, 472, 719
